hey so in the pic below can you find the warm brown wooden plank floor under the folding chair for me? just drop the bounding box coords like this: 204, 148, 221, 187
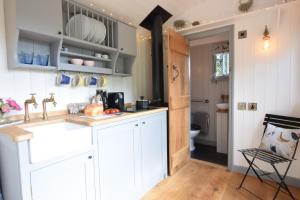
143, 160, 300, 200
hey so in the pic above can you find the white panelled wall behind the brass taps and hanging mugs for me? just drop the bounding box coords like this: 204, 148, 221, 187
0, 0, 151, 114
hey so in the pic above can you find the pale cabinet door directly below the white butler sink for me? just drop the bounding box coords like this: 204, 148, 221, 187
31, 154, 95, 200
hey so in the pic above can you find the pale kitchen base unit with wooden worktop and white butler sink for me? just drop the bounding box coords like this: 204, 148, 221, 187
0, 110, 167, 200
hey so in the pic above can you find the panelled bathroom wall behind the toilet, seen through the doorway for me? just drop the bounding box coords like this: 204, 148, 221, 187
190, 43, 229, 145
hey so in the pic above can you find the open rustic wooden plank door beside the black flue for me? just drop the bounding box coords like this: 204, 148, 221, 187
166, 29, 190, 175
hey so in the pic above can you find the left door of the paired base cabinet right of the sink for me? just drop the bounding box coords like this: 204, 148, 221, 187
97, 122, 139, 200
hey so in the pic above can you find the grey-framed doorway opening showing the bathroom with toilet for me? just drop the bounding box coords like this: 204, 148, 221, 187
186, 26, 234, 168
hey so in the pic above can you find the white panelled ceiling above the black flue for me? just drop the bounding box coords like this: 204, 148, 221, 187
77, 0, 284, 33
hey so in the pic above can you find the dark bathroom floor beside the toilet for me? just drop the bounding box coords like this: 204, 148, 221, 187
191, 144, 227, 166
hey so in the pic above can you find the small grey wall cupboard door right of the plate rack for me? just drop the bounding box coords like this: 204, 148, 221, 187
118, 22, 137, 56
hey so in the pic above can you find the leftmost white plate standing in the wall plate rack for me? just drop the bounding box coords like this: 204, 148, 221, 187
66, 14, 91, 39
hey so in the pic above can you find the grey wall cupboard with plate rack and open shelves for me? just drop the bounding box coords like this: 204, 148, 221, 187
4, 0, 137, 76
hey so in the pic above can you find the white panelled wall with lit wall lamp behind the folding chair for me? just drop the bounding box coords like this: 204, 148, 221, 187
233, 3, 300, 178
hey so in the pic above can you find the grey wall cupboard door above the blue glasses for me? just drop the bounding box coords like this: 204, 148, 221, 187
15, 0, 62, 35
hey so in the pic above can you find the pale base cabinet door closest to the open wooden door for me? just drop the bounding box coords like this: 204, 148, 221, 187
141, 115, 166, 191
